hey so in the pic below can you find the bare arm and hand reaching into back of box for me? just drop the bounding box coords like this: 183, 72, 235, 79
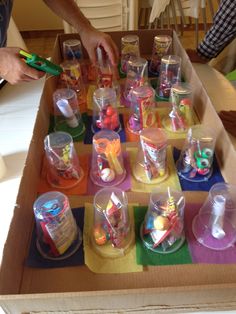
44, 0, 119, 64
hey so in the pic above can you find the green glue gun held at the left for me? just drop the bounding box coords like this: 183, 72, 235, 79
20, 50, 63, 75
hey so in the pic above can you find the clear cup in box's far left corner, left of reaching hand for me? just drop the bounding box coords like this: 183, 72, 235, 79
63, 39, 83, 61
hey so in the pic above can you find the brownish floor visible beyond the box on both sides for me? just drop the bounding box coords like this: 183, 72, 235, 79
22, 30, 204, 58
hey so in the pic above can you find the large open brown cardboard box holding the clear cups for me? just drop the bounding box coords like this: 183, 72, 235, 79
0, 30, 236, 313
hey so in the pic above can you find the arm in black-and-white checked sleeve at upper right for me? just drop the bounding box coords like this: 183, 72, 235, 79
187, 0, 236, 63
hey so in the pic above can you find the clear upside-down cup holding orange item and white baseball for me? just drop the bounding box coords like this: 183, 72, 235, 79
90, 130, 126, 187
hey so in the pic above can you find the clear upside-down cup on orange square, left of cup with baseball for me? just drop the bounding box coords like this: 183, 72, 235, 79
44, 132, 84, 189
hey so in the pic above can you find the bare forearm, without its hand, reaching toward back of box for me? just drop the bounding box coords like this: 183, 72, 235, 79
43, 0, 93, 34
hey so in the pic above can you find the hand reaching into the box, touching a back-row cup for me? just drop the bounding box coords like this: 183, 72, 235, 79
80, 26, 119, 65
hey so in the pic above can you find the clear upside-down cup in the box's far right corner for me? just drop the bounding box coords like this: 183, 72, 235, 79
149, 35, 172, 75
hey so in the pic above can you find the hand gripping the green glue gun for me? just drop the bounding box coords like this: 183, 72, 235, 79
0, 48, 45, 85
